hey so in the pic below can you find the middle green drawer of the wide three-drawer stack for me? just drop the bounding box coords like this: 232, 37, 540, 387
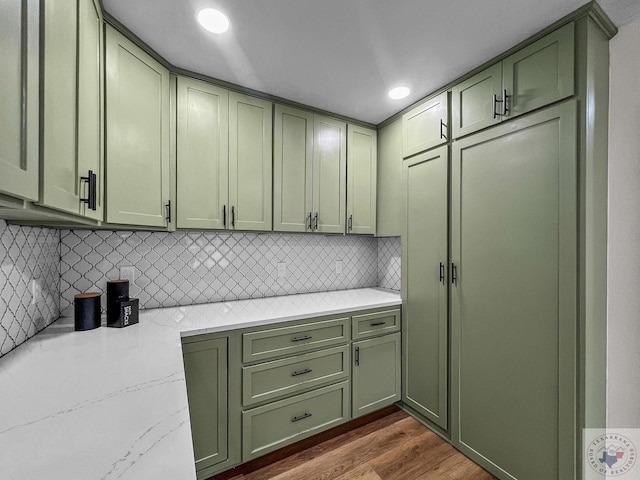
242, 345, 349, 406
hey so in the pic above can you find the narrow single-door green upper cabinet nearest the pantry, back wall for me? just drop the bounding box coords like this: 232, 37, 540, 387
347, 125, 378, 235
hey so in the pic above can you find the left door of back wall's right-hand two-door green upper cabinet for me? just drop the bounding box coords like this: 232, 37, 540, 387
273, 105, 313, 232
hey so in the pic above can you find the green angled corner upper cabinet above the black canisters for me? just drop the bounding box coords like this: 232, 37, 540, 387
106, 26, 171, 227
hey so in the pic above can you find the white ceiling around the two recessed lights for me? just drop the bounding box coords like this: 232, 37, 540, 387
103, 0, 640, 124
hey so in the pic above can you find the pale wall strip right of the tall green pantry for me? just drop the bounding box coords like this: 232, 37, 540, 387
607, 20, 640, 428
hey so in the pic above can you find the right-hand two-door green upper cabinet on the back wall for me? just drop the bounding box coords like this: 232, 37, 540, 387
273, 105, 347, 233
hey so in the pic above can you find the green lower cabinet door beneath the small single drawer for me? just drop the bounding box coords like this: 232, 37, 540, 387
351, 333, 401, 418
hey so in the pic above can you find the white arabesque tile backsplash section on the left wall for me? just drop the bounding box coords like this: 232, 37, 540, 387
0, 220, 60, 356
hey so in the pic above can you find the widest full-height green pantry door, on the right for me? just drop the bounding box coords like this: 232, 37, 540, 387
448, 101, 579, 480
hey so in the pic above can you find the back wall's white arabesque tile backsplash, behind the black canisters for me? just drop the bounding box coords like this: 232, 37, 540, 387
60, 230, 378, 315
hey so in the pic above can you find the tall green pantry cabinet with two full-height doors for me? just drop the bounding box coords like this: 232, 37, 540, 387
402, 11, 615, 480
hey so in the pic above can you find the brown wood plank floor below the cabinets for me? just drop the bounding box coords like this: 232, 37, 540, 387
222, 411, 496, 480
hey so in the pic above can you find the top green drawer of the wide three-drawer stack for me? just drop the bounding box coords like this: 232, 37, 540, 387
242, 317, 349, 363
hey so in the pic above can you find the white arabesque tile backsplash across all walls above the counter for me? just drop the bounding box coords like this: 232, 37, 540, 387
0, 220, 400, 356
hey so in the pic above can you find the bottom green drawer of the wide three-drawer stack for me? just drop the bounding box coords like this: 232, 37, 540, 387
242, 382, 350, 462
